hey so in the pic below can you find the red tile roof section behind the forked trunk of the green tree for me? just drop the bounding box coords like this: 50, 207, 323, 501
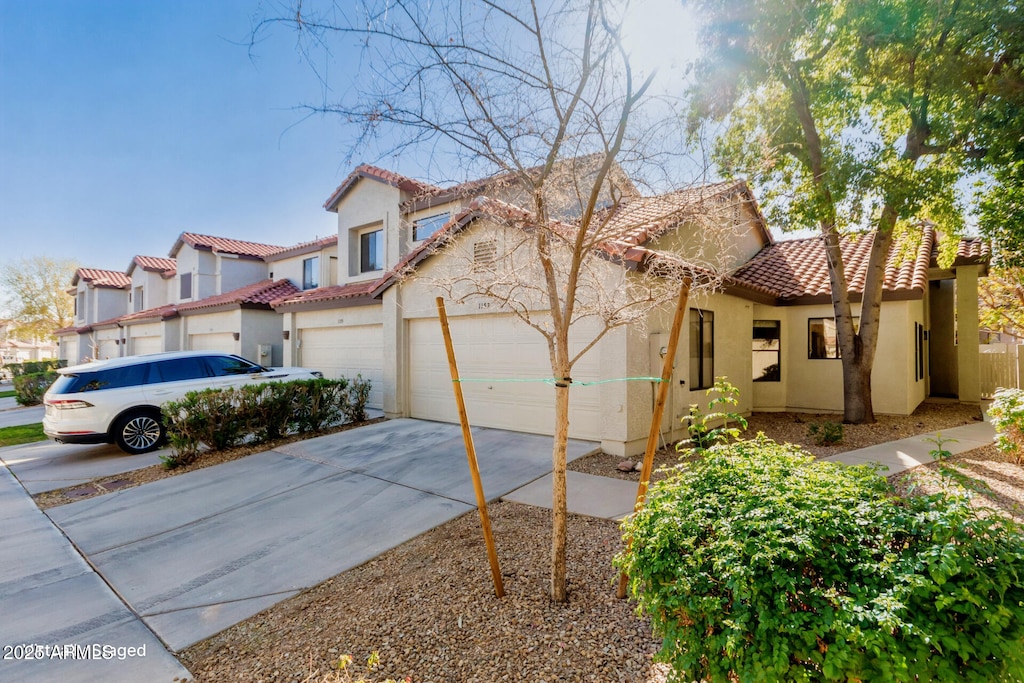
730, 227, 935, 302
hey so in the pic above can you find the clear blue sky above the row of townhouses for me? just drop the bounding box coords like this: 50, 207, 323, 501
0, 0, 687, 278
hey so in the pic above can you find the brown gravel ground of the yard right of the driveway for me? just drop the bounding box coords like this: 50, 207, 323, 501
174, 403, 1007, 683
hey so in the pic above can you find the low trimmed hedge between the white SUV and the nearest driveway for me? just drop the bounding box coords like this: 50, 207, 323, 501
161, 376, 370, 468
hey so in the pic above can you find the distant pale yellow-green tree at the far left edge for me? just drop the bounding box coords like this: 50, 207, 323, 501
0, 256, 78, 339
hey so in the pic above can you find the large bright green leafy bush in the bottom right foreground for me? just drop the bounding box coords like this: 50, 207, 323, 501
615, 436, 1024, 682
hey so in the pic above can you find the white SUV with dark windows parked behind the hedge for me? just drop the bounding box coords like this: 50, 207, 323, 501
43, 351, 324, 454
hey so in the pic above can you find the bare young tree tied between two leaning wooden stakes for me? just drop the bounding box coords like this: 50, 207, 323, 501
257, 0, 722, 601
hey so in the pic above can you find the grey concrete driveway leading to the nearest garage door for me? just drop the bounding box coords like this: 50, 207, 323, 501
47, 420, 597, 651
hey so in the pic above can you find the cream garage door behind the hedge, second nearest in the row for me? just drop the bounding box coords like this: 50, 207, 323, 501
298, 325, 384, 409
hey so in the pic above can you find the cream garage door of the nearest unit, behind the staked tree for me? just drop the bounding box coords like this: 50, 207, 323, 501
409, 315, 601, 439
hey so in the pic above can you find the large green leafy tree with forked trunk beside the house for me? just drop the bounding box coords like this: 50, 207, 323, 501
690, 0, 1024, 423
